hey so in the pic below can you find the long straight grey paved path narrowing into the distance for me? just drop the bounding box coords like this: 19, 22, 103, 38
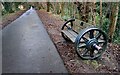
2, 9, 67, 73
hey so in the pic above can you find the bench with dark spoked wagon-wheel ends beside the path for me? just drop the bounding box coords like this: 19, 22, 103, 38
61, 19, 107, 59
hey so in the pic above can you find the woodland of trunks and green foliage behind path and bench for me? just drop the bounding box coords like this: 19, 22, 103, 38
0, 0, 120, 44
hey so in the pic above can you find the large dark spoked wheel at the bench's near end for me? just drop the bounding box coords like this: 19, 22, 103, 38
75, 27, 107, 60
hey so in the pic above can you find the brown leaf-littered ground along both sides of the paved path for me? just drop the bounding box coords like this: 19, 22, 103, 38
2, 10, 120, 73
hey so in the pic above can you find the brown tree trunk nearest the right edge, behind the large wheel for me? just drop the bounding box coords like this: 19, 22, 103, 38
109, 3, 119, 42
